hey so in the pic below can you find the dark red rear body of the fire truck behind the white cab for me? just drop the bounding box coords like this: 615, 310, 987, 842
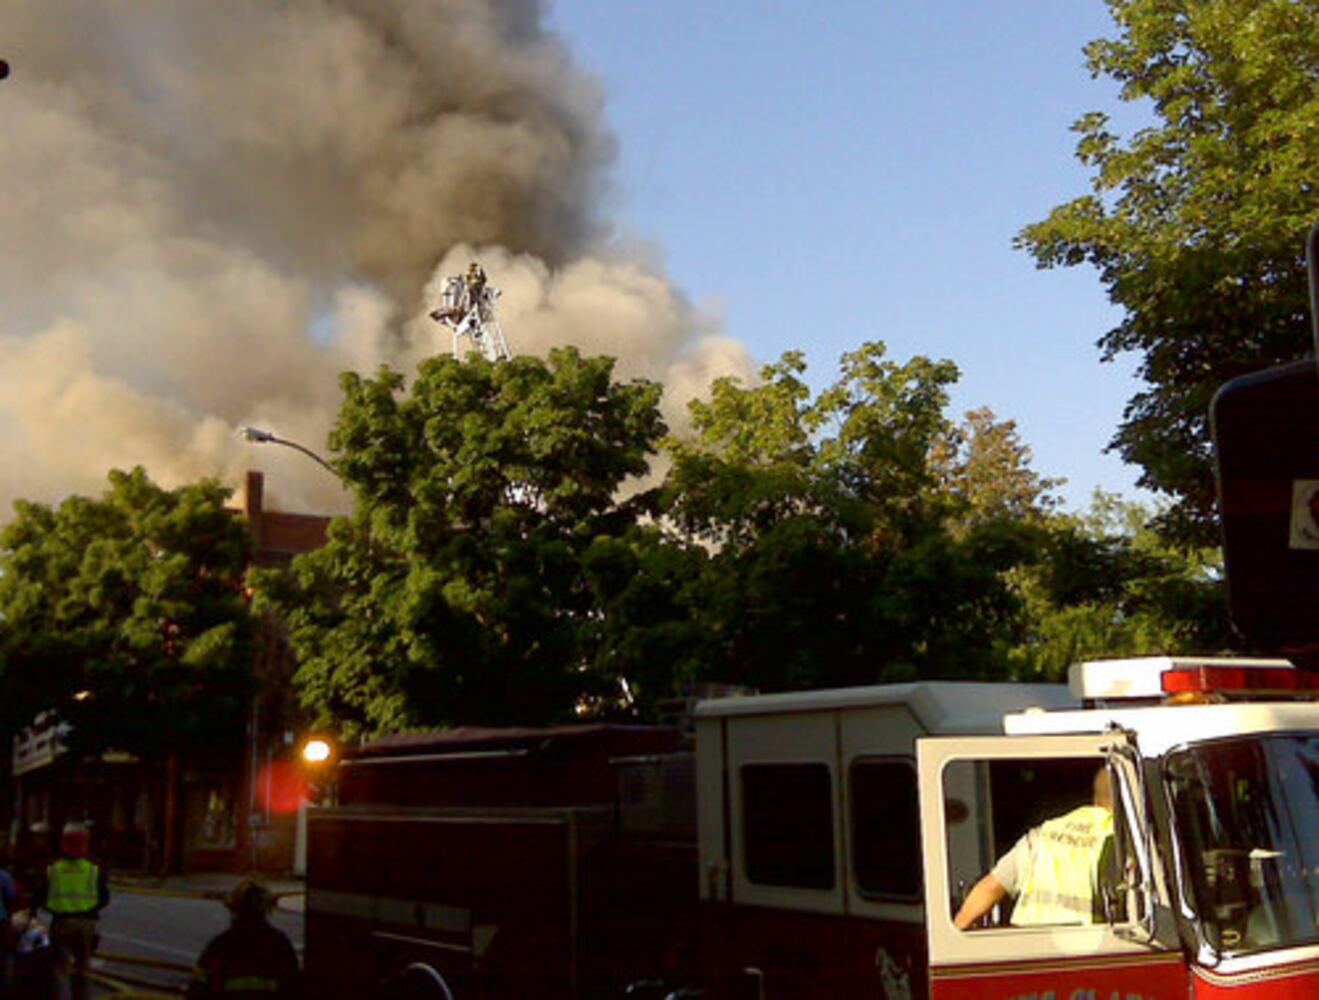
306, 726, 698, 1000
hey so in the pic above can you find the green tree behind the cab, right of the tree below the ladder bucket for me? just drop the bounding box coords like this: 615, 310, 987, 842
663, 343, 1028, 690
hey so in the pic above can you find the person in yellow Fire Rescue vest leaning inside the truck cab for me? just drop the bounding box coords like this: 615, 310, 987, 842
952, 768, 1113, 930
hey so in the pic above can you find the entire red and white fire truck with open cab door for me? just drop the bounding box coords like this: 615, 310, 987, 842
306, 657, 1319, 1000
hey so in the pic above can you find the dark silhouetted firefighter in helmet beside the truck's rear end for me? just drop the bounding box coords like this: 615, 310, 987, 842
187, 880, 298, 1000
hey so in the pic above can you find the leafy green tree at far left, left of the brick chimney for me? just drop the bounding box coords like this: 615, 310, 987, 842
0, 468, 253, 756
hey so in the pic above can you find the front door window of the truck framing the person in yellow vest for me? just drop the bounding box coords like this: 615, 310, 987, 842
943, 757, 1115, 929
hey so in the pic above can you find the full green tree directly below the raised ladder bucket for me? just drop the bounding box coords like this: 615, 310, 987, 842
253, 348, 665, 736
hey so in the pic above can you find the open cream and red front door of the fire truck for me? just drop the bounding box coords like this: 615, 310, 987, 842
917, 734, 1187, 1000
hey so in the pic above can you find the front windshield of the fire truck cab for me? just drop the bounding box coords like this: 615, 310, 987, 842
1166, 735, 1319, 953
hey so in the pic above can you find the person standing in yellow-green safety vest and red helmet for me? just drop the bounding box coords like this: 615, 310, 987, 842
42, 823, 109, 1000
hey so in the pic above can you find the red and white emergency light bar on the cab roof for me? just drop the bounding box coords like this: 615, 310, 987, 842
1067, 656, 1297, 702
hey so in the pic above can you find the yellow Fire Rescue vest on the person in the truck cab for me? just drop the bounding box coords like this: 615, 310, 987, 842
1012, 806, 1113, 926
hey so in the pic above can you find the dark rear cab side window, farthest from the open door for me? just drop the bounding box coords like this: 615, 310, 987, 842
741, 764, 834, 889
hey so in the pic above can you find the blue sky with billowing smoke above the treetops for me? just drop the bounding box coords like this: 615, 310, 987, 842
0, 0, 1155, 517
